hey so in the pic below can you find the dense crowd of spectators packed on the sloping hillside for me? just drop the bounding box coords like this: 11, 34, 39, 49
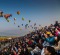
0, 21, 60, 55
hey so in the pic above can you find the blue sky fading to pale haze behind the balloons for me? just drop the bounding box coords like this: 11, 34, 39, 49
0, 0, 60, 36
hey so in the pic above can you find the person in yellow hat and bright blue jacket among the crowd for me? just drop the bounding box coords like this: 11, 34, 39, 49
45, 32, 56, 46
